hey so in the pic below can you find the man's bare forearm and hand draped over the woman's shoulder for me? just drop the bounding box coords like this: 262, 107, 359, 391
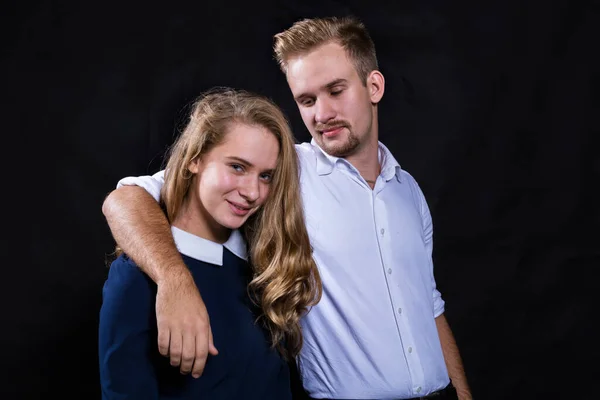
102, 186, 217, 377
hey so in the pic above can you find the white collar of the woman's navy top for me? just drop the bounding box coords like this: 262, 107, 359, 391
171, 226, 247, 266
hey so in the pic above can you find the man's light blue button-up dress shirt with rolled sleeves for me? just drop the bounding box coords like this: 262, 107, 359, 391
118, 141, 450, 399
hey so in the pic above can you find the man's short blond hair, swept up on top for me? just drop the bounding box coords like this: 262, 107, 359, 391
273, 17, 378, 84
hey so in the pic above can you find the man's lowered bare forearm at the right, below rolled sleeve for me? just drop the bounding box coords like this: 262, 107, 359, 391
435, 314, 472, 400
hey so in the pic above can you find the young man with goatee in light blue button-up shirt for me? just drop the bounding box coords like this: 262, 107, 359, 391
103, 18, 471, 400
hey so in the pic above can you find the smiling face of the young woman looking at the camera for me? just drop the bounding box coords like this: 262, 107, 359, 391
189, 123, 279, 239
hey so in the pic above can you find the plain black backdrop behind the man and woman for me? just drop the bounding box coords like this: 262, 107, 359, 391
0, 0, 600, 399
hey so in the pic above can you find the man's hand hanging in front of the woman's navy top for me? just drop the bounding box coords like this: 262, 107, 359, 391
156, 275, 219, 378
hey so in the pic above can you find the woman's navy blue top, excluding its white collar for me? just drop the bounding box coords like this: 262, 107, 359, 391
99, 248, 291, 400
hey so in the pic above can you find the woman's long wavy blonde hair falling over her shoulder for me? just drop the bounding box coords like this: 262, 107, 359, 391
161, 88, 322, 359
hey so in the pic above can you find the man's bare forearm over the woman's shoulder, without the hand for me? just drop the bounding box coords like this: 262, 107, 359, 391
102, 186, 189, 283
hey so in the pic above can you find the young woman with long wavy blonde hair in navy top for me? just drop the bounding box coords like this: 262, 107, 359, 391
99, 89, 321, 400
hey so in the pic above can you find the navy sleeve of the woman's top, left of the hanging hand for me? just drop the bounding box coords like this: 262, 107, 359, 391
98, 256, 158, 400
